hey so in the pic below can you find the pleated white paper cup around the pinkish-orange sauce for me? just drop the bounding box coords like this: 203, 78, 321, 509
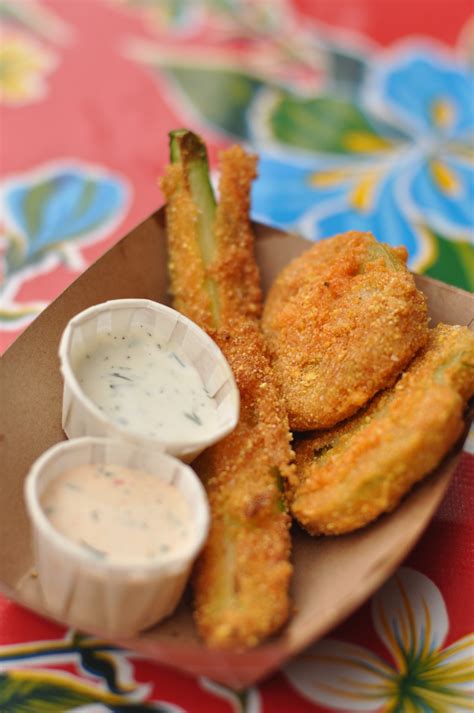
25, 438, 209, 638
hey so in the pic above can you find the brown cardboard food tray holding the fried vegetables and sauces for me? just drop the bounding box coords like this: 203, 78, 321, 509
0, 209, 474, 688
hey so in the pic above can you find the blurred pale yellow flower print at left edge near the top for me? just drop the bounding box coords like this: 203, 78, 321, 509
0, 34, 56, 106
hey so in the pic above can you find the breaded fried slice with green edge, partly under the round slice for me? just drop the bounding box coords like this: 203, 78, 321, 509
291, 324, 474, 535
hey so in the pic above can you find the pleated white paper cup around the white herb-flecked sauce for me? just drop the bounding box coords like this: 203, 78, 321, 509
59, 299, 239, 463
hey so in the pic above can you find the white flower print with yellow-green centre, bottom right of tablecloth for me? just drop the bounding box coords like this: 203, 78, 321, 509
285, 567, 474, 713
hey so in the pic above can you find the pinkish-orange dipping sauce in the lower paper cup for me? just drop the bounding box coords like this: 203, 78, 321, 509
41, 465, 193, 563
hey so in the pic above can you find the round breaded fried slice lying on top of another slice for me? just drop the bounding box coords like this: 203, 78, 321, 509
262, 232, 428, 431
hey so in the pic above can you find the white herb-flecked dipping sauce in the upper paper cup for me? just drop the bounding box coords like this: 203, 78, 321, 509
75, 326, 218, 440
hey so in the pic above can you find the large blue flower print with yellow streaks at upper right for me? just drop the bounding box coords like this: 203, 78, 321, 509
253, 48, 474, 287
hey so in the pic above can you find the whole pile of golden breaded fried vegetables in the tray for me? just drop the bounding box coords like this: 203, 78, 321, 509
161, 129, 474, 648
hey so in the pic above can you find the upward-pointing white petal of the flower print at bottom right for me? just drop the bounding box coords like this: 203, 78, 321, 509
372, 567, 449, 673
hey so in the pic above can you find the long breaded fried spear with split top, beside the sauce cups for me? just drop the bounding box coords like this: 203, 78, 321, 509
161, 131, 294, 648
